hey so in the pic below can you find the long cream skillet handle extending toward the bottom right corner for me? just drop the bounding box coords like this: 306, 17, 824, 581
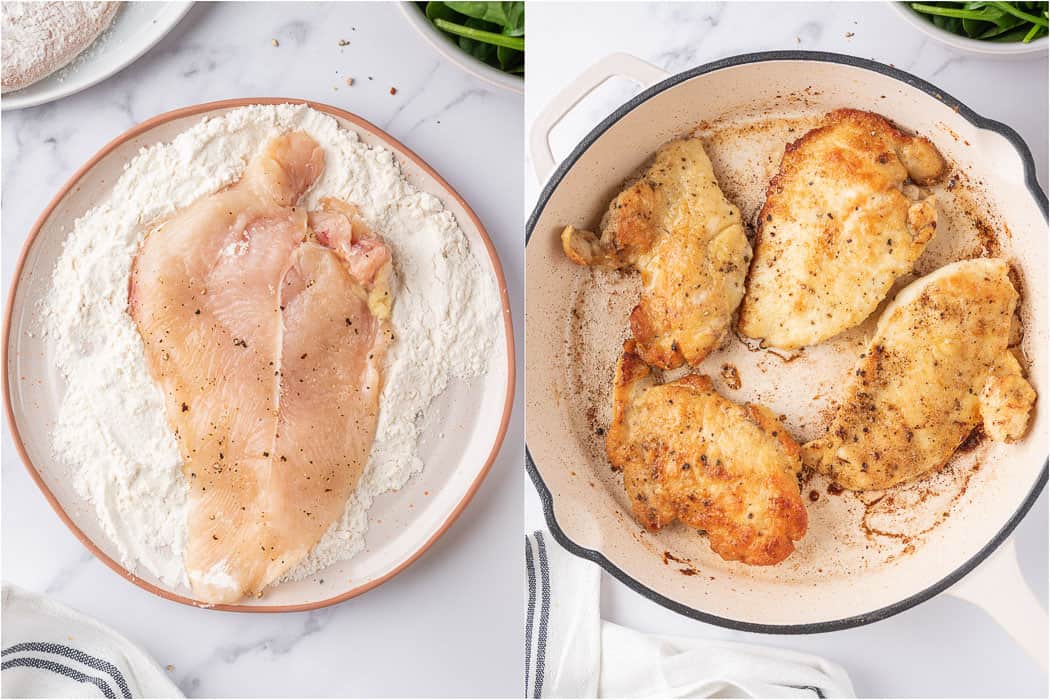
948, 537, 1050, 671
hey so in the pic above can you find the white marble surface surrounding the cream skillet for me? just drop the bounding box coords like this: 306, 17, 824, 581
525, 2, 1048, 698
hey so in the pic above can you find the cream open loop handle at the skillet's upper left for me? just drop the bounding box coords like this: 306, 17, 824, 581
529, 54, 669, 185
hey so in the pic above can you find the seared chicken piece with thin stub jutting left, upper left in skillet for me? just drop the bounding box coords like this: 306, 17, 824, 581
562, 139, 751, 369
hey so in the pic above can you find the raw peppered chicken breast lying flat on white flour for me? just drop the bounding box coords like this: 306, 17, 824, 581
129, 132, 391, 602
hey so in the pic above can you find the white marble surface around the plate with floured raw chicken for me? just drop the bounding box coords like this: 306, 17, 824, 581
2, 3, 523, 697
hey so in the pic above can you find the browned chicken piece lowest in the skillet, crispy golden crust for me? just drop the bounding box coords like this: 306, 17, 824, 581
606, 341, 807, 565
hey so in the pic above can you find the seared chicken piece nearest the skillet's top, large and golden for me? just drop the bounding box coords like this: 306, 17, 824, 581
738, 109, 945, 349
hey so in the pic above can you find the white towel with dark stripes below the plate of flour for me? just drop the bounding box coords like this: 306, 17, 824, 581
0, 582, 183, 698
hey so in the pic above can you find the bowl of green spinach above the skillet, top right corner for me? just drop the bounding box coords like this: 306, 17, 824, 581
893, 0, 1050, 56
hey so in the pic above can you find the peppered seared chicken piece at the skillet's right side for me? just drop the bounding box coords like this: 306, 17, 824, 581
802, 258, 1035, 490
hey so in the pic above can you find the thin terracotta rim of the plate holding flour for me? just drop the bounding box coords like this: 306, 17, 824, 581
0, 98, 517, 613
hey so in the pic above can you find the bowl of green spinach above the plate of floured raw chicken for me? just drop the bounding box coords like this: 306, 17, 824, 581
401, 2, 525, 92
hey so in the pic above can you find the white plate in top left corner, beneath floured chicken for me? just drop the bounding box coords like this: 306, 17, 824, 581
0, 2, 193, 111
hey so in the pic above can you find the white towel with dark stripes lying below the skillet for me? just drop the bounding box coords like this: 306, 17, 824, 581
525, 532, 855, 698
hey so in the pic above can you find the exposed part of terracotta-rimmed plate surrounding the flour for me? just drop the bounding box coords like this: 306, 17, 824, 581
3, 99, 515, 612
